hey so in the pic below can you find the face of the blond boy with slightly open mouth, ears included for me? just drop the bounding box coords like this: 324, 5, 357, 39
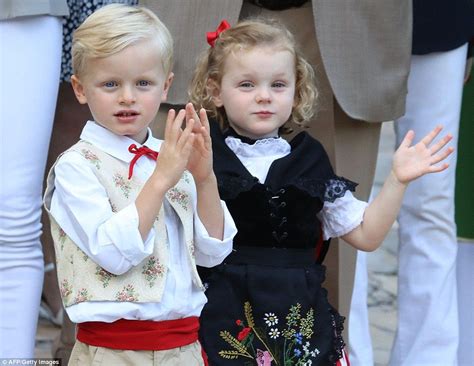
71, 40, 173, 143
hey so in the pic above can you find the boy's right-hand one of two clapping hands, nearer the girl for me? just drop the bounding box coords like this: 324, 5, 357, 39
186, 103, 213, 185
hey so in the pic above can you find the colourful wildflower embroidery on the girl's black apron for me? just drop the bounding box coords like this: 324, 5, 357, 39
219, 301, 320, 366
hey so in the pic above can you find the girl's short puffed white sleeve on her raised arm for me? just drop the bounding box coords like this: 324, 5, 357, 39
318, 191, 368, 240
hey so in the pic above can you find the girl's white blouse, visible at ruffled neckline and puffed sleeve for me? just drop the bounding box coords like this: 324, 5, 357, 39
225, 136, 367, 240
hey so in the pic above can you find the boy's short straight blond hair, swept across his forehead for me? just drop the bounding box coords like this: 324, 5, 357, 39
72, 4, 173, 76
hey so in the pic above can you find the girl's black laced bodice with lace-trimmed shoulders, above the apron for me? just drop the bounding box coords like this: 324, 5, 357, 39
211, 123, 356, 248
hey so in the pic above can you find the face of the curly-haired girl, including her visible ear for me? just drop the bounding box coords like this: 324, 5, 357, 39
211, 46, 295, 139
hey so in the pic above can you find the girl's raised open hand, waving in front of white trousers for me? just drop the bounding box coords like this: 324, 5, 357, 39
392, 126, 454, 184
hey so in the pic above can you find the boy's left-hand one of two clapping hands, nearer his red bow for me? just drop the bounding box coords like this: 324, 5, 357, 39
153, 109, 195, 190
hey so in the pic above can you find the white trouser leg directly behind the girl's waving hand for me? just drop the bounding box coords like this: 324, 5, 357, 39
390, 45, 467, 366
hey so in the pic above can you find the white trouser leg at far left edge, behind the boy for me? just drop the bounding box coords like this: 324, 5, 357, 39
0, 15, 62, 358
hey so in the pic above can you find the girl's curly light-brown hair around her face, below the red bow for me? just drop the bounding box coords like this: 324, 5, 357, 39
189, 18, 318, 133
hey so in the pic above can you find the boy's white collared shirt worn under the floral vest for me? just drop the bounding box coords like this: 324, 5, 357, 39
50, 121, 237, 323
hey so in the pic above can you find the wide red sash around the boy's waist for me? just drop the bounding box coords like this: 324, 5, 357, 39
77, 317, 199, 351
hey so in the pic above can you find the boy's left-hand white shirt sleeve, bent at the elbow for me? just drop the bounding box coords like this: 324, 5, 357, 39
50, 152, 154, 275
